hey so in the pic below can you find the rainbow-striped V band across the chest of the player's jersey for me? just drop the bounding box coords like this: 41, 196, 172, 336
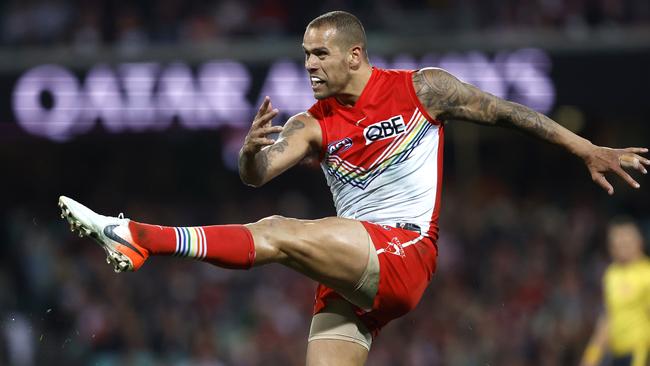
325, 109, 432, 189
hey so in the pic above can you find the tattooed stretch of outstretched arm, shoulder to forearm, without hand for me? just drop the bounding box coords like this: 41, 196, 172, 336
413, 69, 559, 142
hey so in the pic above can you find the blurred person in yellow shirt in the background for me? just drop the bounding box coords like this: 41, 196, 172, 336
582, 218, 650, 366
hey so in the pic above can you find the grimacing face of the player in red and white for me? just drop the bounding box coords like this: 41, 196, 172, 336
302, 26, 351, 99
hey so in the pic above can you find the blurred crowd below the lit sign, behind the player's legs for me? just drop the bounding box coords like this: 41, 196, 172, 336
0, 124, 650, 366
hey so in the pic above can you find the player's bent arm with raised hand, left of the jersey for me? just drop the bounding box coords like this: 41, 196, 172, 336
239, 97, 321, 187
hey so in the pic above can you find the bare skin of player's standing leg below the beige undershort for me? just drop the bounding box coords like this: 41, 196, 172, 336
307, 339, 368, 366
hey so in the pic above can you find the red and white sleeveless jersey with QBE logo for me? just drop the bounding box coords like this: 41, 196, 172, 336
309, 68, 443, 239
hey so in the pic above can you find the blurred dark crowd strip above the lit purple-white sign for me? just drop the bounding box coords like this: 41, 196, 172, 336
0, 0, 650, 50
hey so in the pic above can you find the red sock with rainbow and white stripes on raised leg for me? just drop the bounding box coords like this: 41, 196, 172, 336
129, 221, 255, 269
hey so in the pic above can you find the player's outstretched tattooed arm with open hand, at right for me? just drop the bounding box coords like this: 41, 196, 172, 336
413, 68, 650, 194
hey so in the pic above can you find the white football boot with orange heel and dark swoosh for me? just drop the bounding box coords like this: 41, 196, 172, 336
59, 196, 149, 272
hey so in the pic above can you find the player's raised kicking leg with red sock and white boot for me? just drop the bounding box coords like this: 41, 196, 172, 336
59, 197, 378, 307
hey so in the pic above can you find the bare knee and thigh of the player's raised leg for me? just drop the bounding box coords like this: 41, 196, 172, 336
248, 216, 370, 288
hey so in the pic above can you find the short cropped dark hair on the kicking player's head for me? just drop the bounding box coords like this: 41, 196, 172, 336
307, 10, 368, 55
